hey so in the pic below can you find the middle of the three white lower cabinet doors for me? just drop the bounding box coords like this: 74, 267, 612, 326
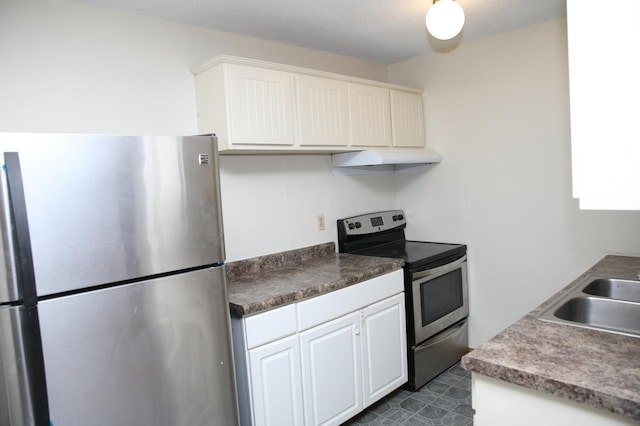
300, 312, 363, 426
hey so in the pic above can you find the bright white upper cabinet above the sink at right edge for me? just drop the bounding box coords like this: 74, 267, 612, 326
567, 0, 640, 210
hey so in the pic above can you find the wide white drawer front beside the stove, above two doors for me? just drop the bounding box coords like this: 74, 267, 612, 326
297, 269, 404, 331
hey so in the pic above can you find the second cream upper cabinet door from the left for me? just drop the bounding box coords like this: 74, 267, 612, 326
295, 75, 349, 146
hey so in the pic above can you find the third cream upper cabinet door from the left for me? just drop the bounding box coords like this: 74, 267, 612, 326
349, 84, 392, 147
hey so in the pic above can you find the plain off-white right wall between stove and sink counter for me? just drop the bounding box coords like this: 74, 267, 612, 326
389, 19, 640, 347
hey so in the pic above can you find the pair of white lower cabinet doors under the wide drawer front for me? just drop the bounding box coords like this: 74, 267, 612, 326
300, 294, 407, 425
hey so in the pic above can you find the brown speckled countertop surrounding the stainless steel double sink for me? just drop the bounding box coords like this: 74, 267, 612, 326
462, 256, 640, 420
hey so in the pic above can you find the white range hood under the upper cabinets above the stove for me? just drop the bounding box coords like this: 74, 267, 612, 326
331, 148, 442, 167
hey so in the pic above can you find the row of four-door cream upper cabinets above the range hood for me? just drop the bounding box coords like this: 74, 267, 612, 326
193, 56, 425, 153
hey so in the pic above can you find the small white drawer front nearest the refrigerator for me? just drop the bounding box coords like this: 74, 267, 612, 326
244, 305, 298, 349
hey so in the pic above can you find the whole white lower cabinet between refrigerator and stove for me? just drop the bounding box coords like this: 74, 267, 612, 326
232, 270, 407, 426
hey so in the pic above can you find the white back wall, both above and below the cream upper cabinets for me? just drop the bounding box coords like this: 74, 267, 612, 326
0, 0, 395, 261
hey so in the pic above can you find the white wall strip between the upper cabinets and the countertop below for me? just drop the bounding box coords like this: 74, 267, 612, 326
222, 155, 395, 259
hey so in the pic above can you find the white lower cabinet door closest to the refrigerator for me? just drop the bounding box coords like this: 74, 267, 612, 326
249, 335, 304, 426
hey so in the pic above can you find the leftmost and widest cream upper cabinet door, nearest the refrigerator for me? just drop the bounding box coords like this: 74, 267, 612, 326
227, 65, 295, 146
